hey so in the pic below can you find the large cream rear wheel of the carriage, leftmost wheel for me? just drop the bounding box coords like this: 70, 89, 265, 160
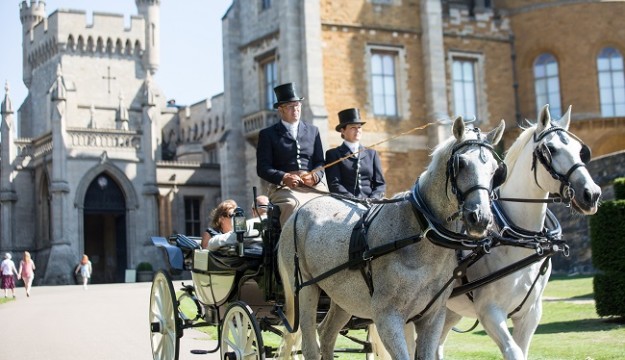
149, 270, 182, 360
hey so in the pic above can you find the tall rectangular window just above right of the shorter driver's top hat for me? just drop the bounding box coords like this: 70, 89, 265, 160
370, 49, 398, 117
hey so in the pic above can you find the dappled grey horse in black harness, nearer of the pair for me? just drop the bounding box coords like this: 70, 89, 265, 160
278, 118, 505, 359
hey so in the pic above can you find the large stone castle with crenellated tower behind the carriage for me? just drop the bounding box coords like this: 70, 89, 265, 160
0, 0, 625, 284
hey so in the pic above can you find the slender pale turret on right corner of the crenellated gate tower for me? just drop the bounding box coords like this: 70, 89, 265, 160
135, 0, 161, 74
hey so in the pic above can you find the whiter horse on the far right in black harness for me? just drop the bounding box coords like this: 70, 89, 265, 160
438, 105, 601, 359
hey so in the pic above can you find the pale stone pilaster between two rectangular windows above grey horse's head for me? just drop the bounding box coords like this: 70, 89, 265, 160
421, 0, 451, 148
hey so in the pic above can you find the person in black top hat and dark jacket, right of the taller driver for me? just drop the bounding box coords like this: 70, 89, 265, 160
326, 108, 386, 199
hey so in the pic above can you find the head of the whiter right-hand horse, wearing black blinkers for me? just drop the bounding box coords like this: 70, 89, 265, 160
532, 105, 601, 215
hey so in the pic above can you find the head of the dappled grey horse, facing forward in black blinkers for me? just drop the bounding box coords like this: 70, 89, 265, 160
434, 117, 506, 237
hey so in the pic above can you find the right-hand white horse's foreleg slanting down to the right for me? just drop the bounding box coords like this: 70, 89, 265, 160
477, 308, 525, 360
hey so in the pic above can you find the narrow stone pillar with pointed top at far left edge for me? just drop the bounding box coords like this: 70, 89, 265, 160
0, 82, 17, 251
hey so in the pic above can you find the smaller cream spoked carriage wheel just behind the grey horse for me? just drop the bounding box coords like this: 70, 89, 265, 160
221, 301, 265, 360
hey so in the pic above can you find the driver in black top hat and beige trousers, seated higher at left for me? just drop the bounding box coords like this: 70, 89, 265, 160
256, 83, 327, 225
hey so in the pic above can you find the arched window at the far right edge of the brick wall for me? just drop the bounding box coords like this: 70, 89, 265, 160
597, 47, 625, 116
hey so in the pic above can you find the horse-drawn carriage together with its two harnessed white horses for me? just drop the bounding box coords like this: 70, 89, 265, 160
150, 110, 600, 360
